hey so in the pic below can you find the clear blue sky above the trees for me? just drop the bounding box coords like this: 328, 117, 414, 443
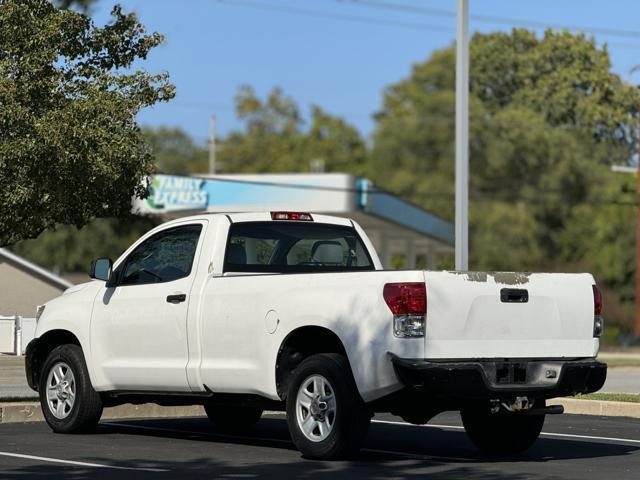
92, 0, 640, 143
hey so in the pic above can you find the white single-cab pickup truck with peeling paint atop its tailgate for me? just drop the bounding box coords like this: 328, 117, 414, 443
26, 212, 607, 458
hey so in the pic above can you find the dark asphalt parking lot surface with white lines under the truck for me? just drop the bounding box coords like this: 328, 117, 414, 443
0, 413, 640, 480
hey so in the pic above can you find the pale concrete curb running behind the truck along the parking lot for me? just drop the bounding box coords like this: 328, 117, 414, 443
0, 398, 640, 424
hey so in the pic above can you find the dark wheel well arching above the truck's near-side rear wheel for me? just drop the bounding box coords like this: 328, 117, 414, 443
276, 326, 348, 400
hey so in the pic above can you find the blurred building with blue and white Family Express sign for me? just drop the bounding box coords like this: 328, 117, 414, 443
134, 173, 454, 269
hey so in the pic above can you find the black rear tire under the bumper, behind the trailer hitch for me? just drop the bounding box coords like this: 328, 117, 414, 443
461, 410, 545, 455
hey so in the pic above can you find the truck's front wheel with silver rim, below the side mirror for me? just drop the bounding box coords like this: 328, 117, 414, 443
38, 345, 102, 433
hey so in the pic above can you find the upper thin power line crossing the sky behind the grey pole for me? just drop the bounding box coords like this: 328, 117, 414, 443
338, 0, 640, 39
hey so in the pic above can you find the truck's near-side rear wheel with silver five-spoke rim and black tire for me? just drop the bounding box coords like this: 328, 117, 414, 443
287, 354, 371, 460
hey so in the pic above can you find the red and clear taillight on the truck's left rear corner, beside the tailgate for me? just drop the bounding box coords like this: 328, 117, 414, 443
382, 282, 427, 338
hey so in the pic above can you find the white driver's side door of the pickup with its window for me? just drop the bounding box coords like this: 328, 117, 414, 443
91, 222, 204, 391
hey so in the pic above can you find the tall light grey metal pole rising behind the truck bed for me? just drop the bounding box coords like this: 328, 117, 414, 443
455, 0, 469, 270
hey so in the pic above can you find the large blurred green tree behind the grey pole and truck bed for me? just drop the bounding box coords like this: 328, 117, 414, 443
369, 29, 640, 328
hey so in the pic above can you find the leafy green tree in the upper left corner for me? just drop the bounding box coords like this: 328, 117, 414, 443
0, 0, 173, 245
